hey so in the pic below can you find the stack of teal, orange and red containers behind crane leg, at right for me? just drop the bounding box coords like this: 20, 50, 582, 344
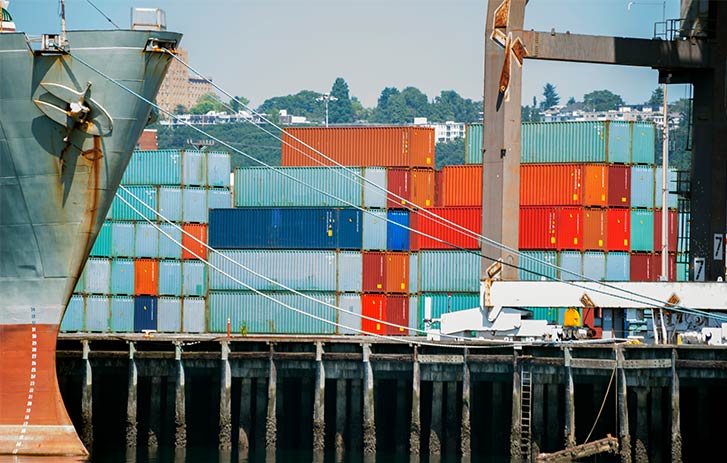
465, 121, 677, 335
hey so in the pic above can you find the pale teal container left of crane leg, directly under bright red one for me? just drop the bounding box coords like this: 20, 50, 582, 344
419, 251, 482, 292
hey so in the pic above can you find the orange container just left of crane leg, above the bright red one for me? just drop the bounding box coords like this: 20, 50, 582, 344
438, 165, 482, 207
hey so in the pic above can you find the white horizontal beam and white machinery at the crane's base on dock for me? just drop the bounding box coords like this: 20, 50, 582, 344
424, 262, 727, 345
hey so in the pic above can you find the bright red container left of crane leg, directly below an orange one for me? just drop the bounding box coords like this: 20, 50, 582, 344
409, 207, 482, 251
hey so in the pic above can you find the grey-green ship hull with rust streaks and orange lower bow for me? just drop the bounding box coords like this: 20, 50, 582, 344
0, 31, 181, 455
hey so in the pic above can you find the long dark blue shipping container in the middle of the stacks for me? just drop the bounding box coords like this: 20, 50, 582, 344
209, 208, 362, 250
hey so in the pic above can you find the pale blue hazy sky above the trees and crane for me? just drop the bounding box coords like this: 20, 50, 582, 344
5, 0, 688, 107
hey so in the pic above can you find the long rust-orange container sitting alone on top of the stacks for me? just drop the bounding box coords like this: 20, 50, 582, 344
282, 127, 434, 167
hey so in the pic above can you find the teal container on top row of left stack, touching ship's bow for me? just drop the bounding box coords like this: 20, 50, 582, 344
121, 150, 182, 185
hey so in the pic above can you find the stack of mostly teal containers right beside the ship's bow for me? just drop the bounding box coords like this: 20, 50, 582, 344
61, 150, 232, 332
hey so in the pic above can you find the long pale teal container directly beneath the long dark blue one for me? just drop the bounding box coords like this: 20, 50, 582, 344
209, 250, 338, 291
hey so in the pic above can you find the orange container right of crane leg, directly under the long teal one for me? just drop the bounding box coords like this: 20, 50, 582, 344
520, 164, 583, 206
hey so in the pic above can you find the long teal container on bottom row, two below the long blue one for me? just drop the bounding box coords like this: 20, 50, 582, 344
207, 291, 338, 334
